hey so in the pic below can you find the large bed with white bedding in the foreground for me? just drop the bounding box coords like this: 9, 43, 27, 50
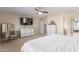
21, 34, 79, 52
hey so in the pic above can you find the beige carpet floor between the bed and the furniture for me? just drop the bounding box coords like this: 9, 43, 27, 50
0, 35, 45, 52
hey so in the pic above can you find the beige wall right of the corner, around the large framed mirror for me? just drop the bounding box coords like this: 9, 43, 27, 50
64, 12, 79, 35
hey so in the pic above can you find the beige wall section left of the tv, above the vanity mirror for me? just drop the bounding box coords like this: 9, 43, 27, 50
0, 12, 20, 31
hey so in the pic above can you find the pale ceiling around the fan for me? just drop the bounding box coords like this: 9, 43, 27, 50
0, 7, 79, 16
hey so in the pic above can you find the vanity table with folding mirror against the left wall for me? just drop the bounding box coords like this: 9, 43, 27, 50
0, 23, 18, 42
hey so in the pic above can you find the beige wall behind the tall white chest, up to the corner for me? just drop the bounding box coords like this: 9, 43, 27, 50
47, 13, 64, 34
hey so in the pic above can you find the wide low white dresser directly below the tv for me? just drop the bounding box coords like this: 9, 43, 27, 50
20, 27, 34, 37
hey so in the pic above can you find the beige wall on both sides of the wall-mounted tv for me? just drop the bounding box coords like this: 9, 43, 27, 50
0, 12, 40, 34
